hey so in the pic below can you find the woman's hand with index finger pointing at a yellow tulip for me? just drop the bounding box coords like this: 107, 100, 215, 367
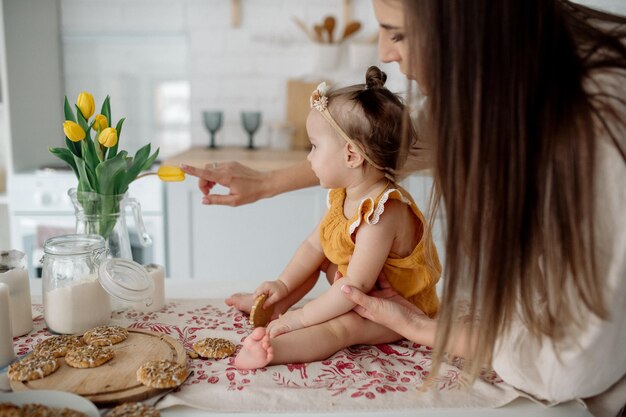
181, 162, 266, 207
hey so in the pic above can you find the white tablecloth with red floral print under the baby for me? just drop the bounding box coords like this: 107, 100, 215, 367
14, 299, 519, 412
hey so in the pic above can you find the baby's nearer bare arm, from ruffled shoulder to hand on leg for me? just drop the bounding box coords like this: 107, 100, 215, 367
269, 201, 400, 336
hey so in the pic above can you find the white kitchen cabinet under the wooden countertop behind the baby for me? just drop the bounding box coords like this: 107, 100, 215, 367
166, 167, 443, 284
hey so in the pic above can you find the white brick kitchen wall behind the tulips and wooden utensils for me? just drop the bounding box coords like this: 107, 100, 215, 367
61, 0, 394, 154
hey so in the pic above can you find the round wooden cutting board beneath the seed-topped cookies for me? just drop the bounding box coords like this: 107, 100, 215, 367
11, 329, 187, 406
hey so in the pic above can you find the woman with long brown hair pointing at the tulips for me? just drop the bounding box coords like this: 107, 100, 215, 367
182, 0, 626, 415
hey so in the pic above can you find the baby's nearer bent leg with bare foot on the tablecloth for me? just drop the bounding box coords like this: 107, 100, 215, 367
235, 312, 402, 369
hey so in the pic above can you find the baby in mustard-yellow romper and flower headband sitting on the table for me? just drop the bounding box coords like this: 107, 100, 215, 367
226, 67, 441, 369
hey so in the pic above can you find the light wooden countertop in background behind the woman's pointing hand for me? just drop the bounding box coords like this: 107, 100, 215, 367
163, 147, 309, 171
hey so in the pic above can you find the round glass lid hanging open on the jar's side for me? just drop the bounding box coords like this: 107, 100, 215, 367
98, 258, 154, 305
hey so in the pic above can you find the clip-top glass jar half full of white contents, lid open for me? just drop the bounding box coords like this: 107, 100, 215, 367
42, 234, 154, 334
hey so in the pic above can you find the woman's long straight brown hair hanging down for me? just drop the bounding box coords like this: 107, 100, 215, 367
404, 0, 626, 375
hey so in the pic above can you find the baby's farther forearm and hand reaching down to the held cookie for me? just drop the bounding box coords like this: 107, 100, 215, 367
254, 224, 326, 307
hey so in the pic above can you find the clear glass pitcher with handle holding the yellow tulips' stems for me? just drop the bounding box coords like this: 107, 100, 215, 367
68, 188, 152, 260
